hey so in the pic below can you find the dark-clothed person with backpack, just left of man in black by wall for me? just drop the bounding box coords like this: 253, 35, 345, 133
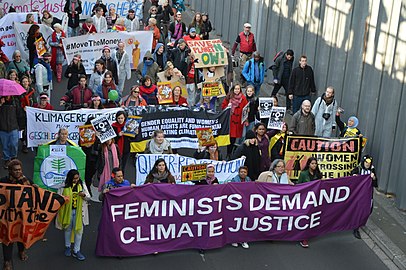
268, 49, 295, 113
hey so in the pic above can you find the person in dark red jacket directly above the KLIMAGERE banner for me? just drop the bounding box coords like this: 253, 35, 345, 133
59, 75, 93, 109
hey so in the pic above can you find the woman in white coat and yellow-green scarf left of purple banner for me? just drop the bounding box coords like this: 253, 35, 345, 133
56, 169, 90, 261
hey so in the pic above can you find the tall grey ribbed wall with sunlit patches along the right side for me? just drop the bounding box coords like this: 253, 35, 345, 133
189, 0, 406, 209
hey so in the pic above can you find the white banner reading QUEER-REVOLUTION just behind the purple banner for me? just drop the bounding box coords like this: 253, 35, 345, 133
135, 154, 245, 186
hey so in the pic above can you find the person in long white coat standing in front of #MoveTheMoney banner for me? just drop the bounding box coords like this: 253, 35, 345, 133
113, 41, 131, 96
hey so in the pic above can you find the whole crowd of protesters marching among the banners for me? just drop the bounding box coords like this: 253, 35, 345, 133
0, 0, 376, 269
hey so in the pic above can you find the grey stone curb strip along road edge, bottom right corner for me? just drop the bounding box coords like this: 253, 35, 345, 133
362, 220, 406, 270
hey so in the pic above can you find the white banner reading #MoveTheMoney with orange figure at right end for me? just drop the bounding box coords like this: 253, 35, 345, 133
62, 31, 152, 74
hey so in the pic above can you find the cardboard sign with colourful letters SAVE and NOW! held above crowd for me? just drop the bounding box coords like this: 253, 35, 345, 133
187, 39, 228, 68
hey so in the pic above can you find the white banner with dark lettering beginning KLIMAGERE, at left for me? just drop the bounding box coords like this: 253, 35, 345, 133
26, 107, 122, 147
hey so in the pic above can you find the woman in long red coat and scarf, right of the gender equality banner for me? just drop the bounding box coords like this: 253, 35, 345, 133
221, 84, 248, 159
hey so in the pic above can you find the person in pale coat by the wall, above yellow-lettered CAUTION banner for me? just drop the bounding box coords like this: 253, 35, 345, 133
312, 86, 338, 138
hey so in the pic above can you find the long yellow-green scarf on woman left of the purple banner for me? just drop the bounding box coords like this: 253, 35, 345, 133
58, 183, 83, 232
